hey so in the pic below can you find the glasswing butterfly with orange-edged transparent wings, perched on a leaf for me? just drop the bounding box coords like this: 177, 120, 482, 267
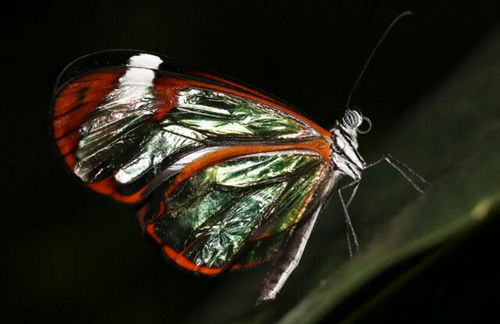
51, 11, 423, 300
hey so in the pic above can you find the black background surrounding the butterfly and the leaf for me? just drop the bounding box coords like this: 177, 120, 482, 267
0, 0, 500, 323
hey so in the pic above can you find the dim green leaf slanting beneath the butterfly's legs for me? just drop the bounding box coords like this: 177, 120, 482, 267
186, 26, 500, 323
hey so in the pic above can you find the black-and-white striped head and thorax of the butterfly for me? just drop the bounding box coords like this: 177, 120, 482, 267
330, 109, 371, 180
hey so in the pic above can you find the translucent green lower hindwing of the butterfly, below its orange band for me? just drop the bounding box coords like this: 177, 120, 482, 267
146, 151, 329, 273
